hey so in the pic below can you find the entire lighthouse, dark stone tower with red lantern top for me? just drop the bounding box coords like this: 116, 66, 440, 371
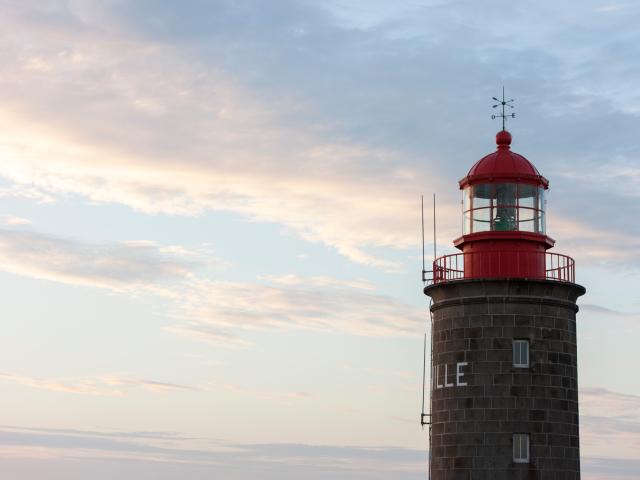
424, 122, 585, 480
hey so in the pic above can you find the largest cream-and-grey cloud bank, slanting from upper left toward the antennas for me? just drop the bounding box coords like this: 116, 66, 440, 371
0, 0, 468, 269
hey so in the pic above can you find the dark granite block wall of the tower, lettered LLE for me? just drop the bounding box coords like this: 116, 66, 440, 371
425, 280, 585, 480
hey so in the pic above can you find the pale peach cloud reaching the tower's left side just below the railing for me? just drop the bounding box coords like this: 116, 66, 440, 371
167, 275, 426, 346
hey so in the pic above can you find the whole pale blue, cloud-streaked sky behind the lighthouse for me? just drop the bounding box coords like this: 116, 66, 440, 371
0, 0, 640, 480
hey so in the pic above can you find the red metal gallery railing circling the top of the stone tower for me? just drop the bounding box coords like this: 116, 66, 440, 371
422, 251, 575, 283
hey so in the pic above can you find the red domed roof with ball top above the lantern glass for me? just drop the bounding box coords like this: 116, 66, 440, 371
460, 130, 549, 188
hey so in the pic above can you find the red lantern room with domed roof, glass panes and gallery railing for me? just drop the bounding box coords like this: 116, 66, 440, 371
433, 130, 574, 283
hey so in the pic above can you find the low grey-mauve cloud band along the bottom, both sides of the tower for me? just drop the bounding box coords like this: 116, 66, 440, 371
0, 426, 640, 480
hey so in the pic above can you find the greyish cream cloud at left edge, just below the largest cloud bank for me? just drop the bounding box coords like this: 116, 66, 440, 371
0, 229, 204, 291
